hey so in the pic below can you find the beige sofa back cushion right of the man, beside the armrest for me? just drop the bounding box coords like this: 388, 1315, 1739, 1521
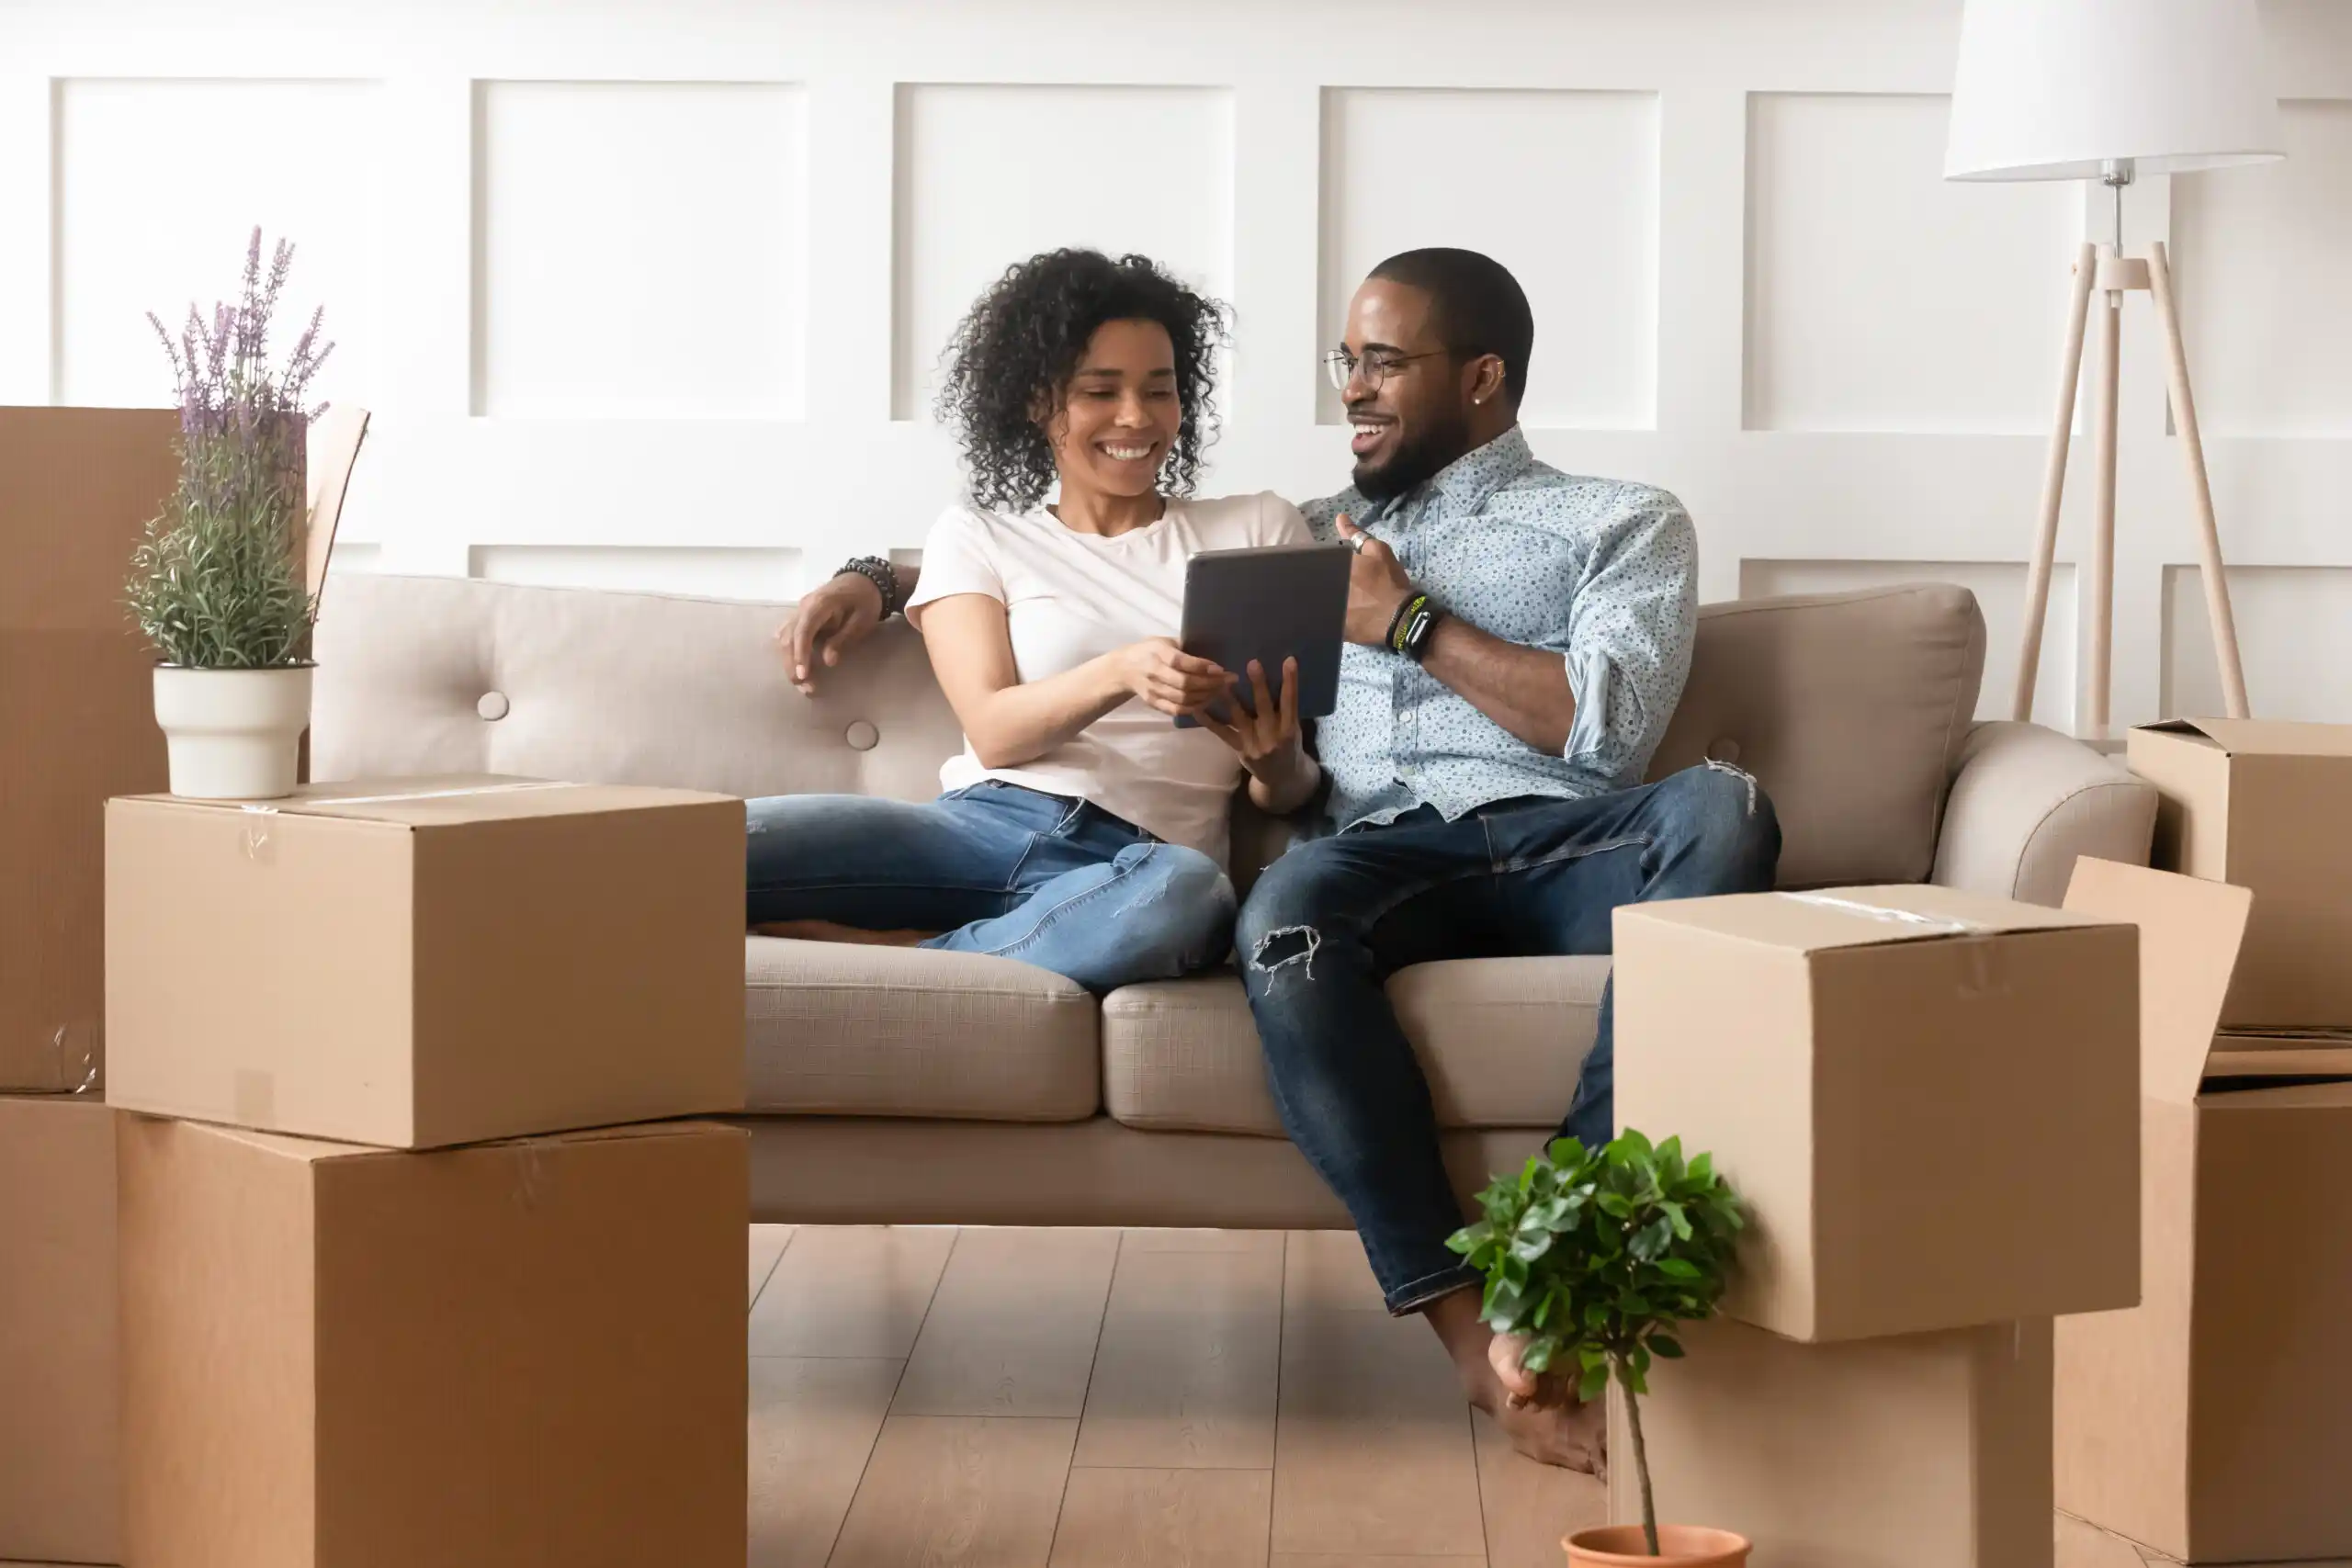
1651, 583, 1985, 886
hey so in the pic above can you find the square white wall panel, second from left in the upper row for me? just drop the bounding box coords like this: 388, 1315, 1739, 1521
473, 83, 809, 421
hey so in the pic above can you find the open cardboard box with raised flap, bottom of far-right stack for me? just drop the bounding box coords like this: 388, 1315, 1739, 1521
2055, 861, 2352, 1563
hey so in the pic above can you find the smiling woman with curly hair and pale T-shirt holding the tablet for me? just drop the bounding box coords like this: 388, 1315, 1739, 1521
748, 252, 1319, 992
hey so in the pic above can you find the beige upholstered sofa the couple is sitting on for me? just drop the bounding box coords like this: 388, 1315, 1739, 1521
312, 576, 2154, 1227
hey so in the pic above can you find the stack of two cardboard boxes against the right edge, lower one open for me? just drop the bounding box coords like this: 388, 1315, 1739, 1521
2055, 719, 2352, 1563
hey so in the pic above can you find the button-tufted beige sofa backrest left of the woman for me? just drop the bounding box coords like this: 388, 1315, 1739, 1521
311, 573, 962, 799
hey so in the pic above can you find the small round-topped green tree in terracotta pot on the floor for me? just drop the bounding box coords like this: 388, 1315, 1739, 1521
1446, 1131, 1747, 1568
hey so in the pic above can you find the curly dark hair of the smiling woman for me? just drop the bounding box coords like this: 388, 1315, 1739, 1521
938, 249, 1227, 510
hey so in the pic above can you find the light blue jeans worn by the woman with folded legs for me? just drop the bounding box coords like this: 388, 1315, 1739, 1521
746, 781, 1232, 995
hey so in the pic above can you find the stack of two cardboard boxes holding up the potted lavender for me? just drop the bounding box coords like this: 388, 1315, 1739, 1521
106, 778, 751, 1568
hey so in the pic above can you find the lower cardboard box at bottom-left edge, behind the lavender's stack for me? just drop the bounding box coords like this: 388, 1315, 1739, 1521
0, 1096, 122, 1563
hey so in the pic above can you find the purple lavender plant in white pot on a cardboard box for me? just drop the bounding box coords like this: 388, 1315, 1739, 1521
130, 228, 334, 799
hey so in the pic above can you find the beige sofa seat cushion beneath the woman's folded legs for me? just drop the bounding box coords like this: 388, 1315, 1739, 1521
743, 936, 1101, 1122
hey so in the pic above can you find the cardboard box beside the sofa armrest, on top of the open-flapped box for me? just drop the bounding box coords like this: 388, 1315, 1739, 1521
2129, 719, 2352, 1034
